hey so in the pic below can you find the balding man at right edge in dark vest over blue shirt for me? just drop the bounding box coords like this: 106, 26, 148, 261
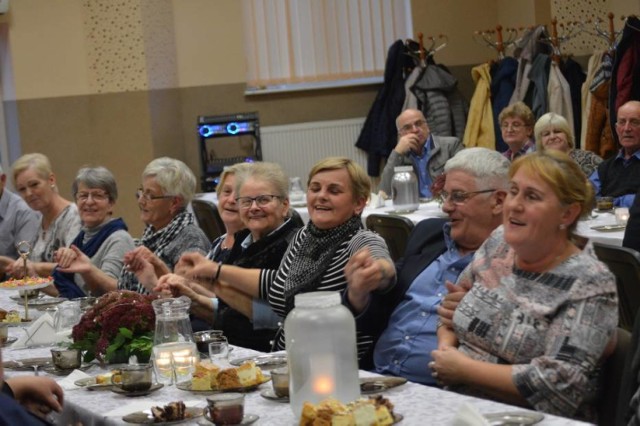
589, 101, 640, 207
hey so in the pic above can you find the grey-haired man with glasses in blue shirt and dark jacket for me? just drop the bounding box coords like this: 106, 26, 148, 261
369, 148, 509, 385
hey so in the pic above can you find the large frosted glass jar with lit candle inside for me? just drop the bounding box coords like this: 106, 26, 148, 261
284, 291, 360, 419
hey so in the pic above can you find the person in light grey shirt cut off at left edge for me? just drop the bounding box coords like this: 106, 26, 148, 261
0, 166, 40, 278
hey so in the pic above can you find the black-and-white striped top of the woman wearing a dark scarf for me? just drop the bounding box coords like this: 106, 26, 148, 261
260, 226, 393, 359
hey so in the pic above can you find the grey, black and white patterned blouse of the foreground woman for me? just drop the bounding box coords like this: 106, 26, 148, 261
453, 226, 618, 420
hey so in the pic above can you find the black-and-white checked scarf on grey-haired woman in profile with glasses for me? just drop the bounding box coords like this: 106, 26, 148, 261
118, 210, 194, 293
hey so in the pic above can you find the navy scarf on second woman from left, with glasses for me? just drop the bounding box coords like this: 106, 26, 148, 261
51, 218, 128, 299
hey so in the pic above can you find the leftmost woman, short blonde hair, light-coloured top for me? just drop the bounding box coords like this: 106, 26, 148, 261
7, 153, 80, 278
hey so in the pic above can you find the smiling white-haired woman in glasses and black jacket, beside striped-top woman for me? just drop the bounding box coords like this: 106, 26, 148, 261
165, 163, 299, 352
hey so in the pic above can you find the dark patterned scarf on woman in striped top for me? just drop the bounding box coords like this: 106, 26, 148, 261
284, 216, 362, 311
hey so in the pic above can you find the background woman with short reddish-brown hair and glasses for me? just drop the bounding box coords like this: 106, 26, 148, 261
498, 102, 536, 161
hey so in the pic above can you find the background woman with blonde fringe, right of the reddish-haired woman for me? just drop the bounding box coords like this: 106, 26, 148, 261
533, 112, 602, 177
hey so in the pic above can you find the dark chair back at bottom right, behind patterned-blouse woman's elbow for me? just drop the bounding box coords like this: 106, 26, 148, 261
596, 327, 631, 426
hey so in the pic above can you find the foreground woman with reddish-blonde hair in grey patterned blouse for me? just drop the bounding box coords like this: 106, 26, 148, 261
429, 150, 618, 421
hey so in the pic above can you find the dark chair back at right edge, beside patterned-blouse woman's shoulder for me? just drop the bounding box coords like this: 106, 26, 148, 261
593, 242, 640, 330
